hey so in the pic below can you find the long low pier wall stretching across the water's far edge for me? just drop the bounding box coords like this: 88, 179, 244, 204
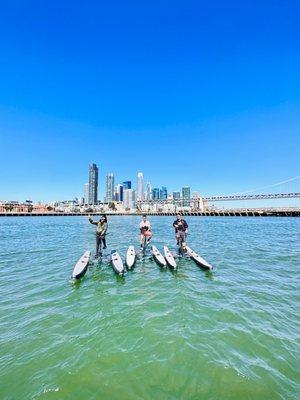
0, 208, 300, 217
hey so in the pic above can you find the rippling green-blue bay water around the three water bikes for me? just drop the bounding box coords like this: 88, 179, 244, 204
0, 217, 300, 400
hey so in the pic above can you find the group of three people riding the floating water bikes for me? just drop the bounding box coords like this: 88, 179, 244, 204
89, 214, 188, 258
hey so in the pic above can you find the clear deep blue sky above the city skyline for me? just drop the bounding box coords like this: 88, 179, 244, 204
0, 0, 300, 201
